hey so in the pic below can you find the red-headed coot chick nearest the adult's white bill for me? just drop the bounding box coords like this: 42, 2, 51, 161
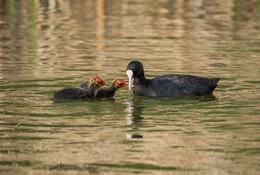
95, 79, 127, 98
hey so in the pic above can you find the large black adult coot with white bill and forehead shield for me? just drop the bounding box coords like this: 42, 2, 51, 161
126, 61, 220, 97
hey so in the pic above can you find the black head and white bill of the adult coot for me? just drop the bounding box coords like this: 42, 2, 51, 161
126, 61, 144, 90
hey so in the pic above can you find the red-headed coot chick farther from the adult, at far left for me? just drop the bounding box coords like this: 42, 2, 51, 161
53, 75, 107, 101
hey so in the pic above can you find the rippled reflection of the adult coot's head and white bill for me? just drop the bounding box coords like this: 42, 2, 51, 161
125, 97, 143, 139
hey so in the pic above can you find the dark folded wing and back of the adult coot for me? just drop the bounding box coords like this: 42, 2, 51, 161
151, 74, 219, 97
